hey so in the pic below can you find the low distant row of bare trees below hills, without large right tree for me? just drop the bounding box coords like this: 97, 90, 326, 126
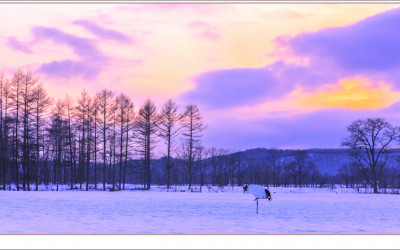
152, 144, 400, 189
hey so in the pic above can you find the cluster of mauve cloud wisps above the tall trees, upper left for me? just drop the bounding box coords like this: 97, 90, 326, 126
8, 20, 138, 80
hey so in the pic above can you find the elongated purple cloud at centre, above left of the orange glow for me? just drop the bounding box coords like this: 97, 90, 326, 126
179, 61, 339, 109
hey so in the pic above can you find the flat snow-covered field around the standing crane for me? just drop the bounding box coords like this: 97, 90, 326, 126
0, 188, 400, 234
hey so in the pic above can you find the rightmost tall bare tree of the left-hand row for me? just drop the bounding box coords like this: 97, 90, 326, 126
182, 104, 206, 189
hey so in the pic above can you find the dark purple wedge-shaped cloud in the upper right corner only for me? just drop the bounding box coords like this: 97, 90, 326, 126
289, 8, 400, 71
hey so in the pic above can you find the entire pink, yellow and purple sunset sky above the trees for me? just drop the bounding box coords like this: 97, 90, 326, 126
0, 3, 400, 150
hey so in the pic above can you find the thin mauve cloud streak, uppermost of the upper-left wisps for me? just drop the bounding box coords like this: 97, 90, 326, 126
73, 20, 132, 43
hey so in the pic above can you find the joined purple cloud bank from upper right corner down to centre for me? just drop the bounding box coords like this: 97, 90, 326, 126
181, 8, 400, 109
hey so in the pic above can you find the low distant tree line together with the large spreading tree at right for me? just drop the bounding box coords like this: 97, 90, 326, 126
145, 118, 400, 193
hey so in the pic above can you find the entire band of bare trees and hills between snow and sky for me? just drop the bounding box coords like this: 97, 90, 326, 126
0, 69, 400, 193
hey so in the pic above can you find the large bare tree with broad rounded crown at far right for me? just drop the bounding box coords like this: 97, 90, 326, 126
342, 118, 400, 193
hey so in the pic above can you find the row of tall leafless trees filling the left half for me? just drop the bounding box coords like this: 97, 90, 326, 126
0, 70, 205, 191
